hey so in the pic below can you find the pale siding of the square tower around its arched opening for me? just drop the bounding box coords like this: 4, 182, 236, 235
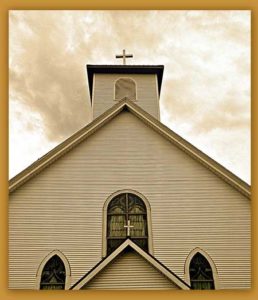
92, 74, 159, 120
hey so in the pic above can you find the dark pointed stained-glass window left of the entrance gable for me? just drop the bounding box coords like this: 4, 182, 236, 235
40, 255, 66, 290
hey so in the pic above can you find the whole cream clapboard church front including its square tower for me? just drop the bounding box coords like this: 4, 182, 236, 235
9, 55, 251, 290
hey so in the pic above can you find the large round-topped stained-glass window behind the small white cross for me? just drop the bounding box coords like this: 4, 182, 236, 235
107, 193, 148, 254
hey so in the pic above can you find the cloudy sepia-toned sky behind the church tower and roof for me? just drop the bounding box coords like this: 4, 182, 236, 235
9, 11, 250, 183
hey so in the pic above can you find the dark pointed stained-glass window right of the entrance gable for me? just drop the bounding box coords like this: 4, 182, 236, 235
189, 252, 215, 290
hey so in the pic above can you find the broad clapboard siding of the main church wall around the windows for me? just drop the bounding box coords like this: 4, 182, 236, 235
9, 112, 251, 289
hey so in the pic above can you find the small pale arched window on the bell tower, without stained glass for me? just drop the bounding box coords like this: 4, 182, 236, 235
115, 77, 136, 100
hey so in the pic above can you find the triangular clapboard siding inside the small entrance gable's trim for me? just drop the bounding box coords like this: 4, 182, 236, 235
82, 252, 179, 290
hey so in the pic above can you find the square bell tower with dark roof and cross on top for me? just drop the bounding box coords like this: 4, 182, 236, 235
87, 50, 164, 120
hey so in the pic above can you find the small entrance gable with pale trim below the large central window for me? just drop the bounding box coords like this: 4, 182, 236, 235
71, 238, 190, 290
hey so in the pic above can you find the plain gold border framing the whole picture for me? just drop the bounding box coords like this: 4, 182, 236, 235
0, 0, 258, 300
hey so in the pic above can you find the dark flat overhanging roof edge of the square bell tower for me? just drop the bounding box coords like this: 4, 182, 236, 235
87, 65, 164, 101
